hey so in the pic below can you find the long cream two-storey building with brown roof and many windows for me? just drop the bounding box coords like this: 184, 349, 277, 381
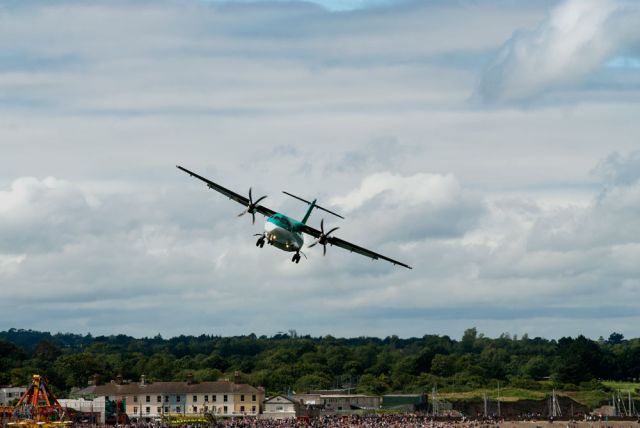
78, 376, 264, 420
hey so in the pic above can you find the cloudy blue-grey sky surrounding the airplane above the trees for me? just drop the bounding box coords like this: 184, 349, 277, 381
0, 0, 640, 338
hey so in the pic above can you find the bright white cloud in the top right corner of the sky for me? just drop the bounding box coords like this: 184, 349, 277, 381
477, 0, 640, 102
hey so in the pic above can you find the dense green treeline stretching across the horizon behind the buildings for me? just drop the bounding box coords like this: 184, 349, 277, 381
0, 328, 640, 394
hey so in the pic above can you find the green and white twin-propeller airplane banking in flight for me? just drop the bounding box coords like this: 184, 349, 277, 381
176, 165, 412, 269
